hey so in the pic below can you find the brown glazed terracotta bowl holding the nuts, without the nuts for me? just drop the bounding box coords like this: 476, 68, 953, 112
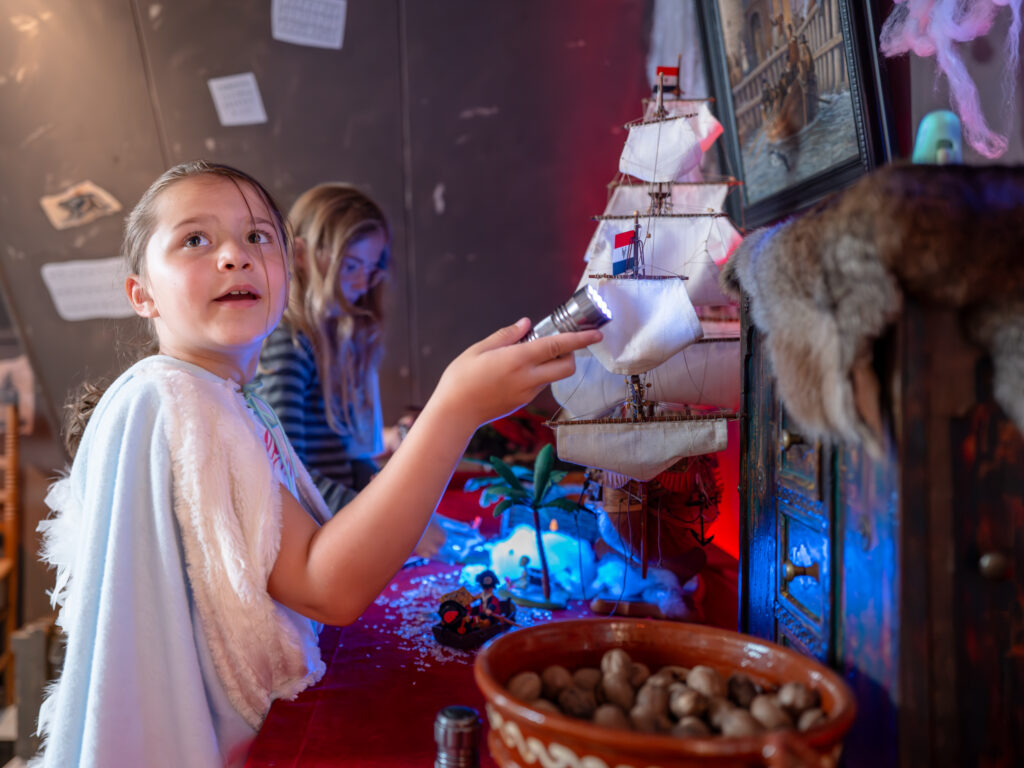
474, 618, 856, 768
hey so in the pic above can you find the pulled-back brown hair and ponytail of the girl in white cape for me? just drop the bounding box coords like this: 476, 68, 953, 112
61, 160, 292, 458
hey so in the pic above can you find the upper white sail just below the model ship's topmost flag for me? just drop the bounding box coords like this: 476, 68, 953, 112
618, 118, 703, 181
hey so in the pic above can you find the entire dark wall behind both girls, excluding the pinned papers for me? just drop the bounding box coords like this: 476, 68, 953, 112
0, 0, 651, 428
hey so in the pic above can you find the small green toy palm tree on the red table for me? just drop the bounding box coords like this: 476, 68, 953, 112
466, 442, 586, 600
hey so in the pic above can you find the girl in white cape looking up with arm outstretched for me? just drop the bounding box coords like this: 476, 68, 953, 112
40, 162, 600, 768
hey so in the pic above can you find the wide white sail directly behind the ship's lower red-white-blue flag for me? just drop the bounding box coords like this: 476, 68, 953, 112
580, 214, 742, 306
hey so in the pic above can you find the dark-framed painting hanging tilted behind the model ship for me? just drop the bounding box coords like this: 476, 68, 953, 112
698, 0, 892, 227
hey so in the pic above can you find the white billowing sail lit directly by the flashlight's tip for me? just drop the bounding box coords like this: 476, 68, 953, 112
588, 278, 703, 376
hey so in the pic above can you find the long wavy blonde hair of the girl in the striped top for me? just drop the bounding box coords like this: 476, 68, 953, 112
284, 182, 391, 433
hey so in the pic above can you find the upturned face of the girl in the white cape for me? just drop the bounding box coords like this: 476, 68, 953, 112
126, 175, 288, 380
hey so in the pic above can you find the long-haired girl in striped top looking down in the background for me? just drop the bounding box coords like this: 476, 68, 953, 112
251, 183, 399, 510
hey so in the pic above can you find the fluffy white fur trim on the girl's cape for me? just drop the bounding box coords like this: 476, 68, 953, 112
39, 356, 330, 753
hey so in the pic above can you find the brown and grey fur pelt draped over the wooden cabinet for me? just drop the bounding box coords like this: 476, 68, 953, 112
721, 165, 1024, 452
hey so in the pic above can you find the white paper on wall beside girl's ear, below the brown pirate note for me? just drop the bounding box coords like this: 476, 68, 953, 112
42, 256, 135, 321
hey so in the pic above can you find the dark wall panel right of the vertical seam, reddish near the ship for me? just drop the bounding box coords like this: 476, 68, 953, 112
402, 0, 650, 403
